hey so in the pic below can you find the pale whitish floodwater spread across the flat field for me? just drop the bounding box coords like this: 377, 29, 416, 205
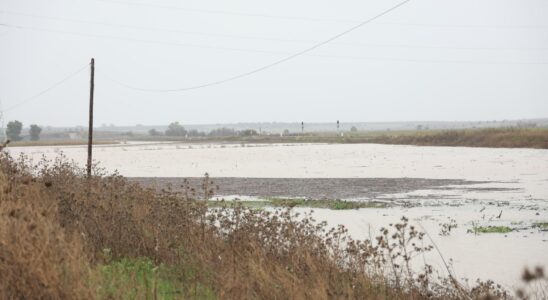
5, 143, 548, 288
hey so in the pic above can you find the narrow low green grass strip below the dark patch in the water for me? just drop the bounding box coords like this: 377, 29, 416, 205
207, 198, 388, 210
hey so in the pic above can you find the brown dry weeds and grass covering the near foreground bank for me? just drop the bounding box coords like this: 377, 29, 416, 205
0, 154, 536, 299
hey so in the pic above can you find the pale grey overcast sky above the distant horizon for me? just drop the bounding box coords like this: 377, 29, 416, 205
0, 0, 548, 126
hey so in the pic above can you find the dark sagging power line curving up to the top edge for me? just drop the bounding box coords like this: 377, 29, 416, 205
104, 0, 416, 92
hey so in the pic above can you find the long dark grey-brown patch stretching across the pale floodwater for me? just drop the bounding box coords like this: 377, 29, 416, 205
128, 177, 494, 200
